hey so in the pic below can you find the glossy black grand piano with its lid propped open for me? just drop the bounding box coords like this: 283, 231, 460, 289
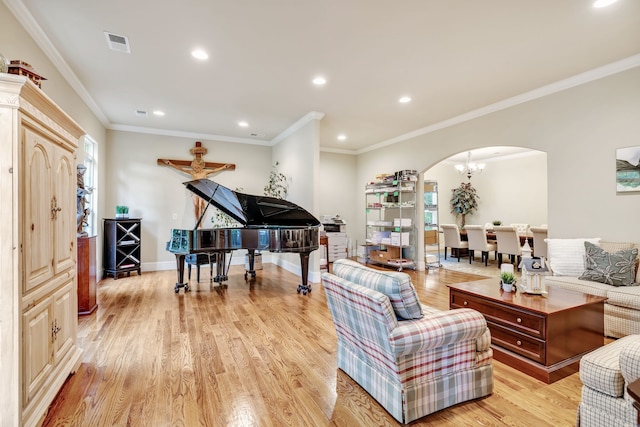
167, 179, 320, 295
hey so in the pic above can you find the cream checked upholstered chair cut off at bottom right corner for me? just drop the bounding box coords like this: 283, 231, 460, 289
576, 335, 640, 427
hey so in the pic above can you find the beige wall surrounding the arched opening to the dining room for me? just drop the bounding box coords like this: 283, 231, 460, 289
356, 68, 640, 260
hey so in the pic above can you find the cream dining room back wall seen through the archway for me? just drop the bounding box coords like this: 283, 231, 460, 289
424, 151, 548, 226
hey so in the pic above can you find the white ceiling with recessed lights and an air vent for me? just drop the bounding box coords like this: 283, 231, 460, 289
4, 0, 640, 153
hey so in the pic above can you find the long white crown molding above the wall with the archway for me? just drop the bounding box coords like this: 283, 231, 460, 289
357, 54, 640, 154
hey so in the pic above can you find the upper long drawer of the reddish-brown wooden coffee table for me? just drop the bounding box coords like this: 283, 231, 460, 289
450, 290, 546, 339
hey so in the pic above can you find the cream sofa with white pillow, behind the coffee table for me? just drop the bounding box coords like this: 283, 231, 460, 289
545, 239, 640, 338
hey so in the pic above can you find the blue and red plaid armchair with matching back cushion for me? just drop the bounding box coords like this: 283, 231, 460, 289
322, 259, 493, 423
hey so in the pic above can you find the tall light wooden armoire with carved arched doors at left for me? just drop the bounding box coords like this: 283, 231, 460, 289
0, 73, 84, 426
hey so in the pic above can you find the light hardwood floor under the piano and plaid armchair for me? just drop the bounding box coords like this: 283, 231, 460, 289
44, 264, 581, 427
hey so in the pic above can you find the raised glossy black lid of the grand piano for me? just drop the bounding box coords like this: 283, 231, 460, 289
184, 178, 320, 227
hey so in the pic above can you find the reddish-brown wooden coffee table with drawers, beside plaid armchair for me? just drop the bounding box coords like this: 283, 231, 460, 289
448, 279, 606, 383
